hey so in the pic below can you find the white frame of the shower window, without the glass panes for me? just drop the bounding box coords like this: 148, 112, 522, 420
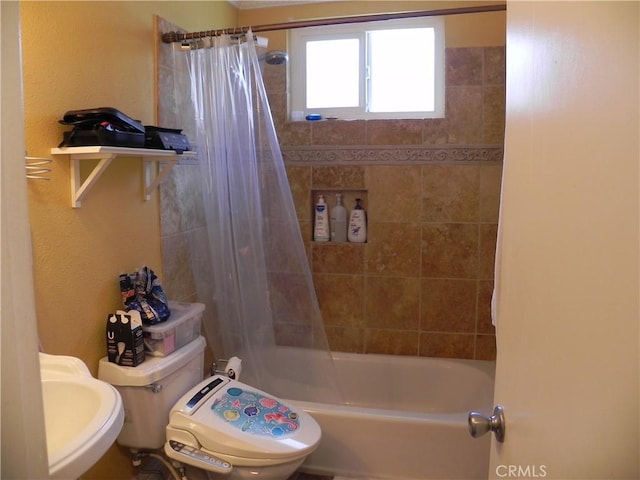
288, 17, 445, 120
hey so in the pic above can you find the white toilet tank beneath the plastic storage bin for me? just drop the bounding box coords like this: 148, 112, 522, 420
98, 336, 206, 450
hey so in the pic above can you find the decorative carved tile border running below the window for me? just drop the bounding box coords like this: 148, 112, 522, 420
282, 145, 504, 166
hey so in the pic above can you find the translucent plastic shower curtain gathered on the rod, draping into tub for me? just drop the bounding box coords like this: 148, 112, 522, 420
174, 32, 340, 403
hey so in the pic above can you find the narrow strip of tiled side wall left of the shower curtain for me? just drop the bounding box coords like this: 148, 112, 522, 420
155, 17, 225, 365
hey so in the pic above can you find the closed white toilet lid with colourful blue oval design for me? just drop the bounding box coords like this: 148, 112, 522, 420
169, 376, 321, 459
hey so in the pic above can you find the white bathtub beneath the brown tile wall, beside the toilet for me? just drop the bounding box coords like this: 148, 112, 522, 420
274, 353, 494, 480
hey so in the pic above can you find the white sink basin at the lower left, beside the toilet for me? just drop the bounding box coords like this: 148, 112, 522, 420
40, 353, 124, 479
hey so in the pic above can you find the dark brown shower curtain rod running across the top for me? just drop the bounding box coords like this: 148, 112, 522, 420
162, 4, 507, 43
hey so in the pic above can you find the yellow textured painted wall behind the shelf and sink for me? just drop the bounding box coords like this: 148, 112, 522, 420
21, 1, 237, 479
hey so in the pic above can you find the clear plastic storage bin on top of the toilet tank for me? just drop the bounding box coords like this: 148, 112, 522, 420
142, 301, 204, 357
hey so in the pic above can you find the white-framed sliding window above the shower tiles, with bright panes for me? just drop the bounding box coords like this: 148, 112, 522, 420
289, 17, 444, 119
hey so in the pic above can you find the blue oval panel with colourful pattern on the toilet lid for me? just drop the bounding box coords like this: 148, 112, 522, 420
211, 387, 300, 438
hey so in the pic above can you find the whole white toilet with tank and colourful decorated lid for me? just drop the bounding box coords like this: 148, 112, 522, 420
98, 336, 321, 480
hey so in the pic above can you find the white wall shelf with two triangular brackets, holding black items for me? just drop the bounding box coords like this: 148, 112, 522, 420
51, 146, 196, 208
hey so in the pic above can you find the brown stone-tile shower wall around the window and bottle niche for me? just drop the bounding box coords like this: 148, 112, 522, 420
159, 37, 505, 359
